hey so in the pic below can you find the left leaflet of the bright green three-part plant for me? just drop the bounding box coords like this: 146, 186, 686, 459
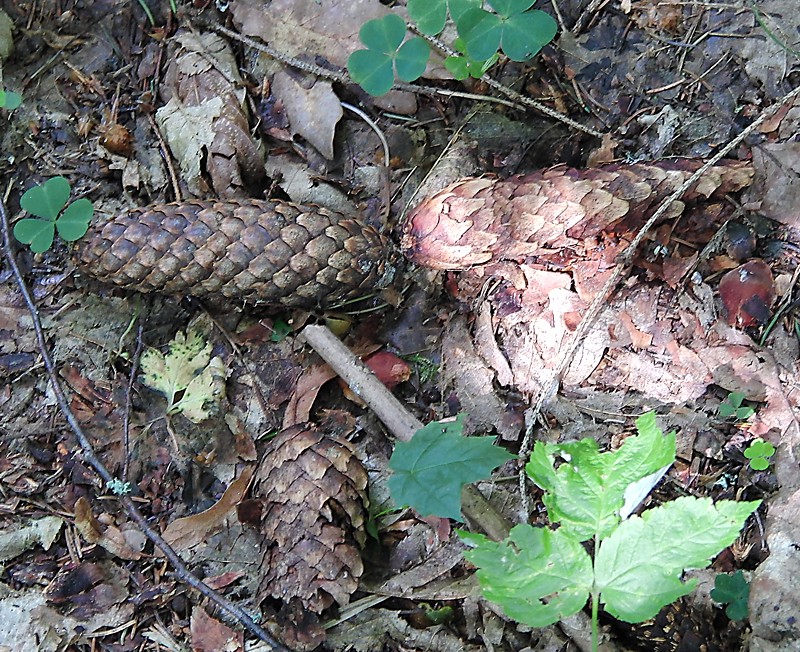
459, 524, 592, 627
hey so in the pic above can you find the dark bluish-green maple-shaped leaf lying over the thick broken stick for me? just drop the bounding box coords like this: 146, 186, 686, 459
389, 415, 514, 521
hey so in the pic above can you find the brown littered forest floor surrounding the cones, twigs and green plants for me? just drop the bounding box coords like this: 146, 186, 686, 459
0, 0, 800, 652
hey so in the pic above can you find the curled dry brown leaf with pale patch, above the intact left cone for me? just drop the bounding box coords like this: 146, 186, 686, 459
156, 32, 266, 197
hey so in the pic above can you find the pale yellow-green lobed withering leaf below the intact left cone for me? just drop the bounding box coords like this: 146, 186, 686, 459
141, 329, 226, 423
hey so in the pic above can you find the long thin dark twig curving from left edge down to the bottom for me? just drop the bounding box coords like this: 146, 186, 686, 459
0, 199, 289, 652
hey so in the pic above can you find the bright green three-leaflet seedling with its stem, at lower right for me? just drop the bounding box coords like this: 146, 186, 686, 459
460, 412, 760, 650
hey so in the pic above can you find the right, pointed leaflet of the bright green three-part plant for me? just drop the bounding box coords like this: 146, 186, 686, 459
595, 497, 761, 623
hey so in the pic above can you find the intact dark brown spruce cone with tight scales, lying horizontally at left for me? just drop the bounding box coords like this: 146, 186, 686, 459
73, 199, 392, 308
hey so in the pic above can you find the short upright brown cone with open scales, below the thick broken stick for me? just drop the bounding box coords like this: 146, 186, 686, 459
253, 425, 368, 648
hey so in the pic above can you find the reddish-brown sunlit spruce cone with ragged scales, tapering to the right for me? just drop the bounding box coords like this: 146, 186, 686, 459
402, 159, 753, 270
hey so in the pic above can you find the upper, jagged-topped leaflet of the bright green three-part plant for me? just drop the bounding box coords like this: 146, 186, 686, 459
525, 412, 675, 541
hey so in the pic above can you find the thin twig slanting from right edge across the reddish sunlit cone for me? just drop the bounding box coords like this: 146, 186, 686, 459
519, 86, 800, 516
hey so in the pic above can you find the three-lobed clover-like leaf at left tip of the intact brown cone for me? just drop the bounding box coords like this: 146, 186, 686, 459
14, 177, 94, 254
